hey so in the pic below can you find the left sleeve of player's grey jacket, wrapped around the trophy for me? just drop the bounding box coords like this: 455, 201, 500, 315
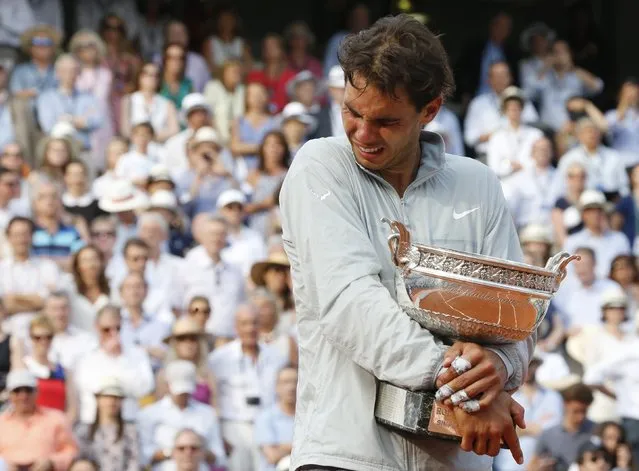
280, 145, 447, 390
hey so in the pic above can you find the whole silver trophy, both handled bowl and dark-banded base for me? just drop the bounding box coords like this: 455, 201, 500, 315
375, 219, 579, 439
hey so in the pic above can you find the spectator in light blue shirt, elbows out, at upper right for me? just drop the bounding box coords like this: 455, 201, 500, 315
530, 41, 604, 131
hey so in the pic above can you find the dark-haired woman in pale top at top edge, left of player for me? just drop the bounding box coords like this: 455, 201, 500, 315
202, 9, 253, 75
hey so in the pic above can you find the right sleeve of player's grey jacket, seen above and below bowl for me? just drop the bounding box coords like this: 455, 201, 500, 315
481, 166, 537, 390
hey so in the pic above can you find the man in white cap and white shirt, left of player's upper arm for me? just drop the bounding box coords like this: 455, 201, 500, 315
217, 189, 268, 277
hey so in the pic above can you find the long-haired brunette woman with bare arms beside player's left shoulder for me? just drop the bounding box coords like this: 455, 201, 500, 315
244, 131, 291, 237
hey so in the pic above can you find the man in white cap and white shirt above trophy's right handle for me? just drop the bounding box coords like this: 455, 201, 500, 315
564, 190, 631, 278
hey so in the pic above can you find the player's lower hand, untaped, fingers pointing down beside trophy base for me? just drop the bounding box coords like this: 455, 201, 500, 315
453, 391, 526, 464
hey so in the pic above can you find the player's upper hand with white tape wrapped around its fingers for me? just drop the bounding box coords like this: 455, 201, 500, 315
435, 342, 508, 409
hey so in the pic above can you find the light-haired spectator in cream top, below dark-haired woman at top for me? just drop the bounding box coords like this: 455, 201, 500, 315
204, 58, 246, 146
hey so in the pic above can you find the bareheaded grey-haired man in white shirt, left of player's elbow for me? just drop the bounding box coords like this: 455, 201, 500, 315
180, 215, 246, 339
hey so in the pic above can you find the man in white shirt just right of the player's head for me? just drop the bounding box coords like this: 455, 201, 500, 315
464, 62, 539, 156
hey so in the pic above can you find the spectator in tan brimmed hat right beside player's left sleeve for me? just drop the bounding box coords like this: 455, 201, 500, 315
251, 250, 293, 313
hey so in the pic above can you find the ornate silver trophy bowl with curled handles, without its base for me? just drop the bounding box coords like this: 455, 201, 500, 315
383, 219, 578, 345
